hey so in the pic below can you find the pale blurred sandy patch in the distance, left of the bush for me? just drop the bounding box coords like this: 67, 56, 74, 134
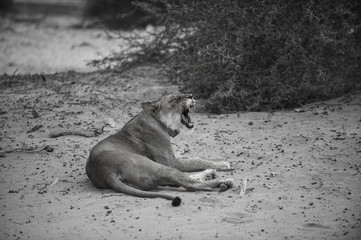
0, 16, 127, 75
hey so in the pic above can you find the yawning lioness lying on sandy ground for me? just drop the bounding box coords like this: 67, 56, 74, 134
86, 94, 233, 206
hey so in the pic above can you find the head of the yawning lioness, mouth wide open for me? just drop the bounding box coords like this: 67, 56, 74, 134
142, 94, 195, 135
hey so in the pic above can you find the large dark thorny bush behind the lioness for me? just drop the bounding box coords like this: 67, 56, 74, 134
78, 0, 361, 112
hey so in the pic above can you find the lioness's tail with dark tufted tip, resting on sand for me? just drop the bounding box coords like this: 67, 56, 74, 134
107, 174, 182, 207
